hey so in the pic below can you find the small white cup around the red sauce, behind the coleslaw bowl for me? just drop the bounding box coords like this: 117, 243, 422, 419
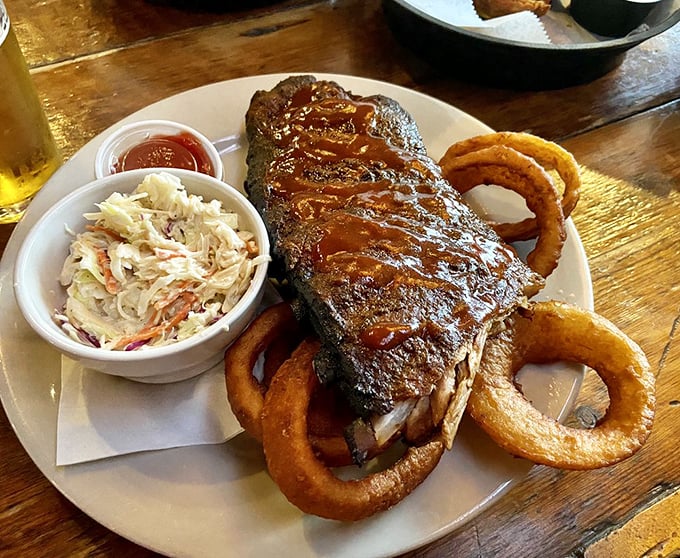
94, 120, 224, 180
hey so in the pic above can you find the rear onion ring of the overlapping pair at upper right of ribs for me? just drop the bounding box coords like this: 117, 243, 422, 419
439, 132, 581, 242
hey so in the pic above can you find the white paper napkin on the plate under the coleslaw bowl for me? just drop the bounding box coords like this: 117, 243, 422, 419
56, 357, 243, 465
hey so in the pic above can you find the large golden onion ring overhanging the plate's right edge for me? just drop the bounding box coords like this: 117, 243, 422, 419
468, 302, 655, 469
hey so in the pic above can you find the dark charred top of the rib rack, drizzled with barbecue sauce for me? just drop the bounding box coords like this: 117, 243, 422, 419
246, 76, 540, 424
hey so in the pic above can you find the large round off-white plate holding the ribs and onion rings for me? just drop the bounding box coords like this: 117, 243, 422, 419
0, 74, 592, 558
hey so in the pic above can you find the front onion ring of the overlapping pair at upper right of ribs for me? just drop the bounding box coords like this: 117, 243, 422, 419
442, 145, 567, 277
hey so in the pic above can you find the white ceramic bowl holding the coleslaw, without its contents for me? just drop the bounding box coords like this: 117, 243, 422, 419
14, 169, 269, 383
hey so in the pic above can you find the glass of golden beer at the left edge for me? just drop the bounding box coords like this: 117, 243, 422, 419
0, 0, 62, 223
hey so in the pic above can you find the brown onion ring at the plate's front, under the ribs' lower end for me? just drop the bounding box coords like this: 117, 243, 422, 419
262, 339, 444, 521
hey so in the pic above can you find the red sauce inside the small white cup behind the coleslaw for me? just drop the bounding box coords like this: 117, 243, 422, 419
112, 132, 214, 176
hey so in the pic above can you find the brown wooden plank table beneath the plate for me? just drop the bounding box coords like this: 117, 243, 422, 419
0, 0, 680, 557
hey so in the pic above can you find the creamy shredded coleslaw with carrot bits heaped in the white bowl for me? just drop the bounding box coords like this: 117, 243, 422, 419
55, 173, 269, 350
